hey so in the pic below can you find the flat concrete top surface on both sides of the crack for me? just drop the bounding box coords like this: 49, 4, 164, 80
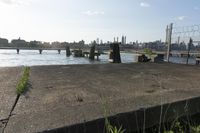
0, 63, 200, 133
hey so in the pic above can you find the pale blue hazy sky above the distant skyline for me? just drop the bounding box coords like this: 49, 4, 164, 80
0, 0, 200, 43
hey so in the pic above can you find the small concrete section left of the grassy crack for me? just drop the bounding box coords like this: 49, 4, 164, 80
0, 67, 21, 132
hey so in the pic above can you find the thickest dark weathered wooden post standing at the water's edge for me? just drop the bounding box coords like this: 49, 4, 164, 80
110, 43, 121, 63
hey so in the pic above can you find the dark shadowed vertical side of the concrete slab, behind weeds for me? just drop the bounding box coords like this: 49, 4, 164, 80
40, 97, 200, 133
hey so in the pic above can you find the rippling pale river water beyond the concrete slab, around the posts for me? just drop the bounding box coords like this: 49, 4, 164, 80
0, 50, 195, 67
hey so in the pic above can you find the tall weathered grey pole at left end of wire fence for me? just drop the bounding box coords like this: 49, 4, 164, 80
166, 23, 173, 62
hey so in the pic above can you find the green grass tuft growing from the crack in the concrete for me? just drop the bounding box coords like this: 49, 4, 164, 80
16, 67, 30, 95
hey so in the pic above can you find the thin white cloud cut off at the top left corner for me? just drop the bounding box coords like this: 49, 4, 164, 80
0, 0, 31, 5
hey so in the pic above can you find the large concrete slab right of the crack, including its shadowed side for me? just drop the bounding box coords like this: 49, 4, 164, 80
2, 63, 200, 133
